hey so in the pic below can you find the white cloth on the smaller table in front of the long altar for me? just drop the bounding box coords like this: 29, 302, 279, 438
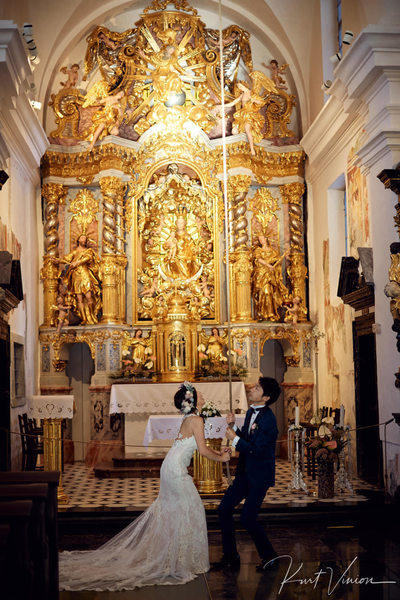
143, 415, 245, 446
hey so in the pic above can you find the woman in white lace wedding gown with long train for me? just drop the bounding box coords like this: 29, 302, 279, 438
60, 381, 230, 592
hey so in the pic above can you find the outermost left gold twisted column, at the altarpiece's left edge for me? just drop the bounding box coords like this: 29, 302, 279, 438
40, 183, 68, 327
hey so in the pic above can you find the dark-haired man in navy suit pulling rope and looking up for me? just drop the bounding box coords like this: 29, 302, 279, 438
214, 377, 281, 571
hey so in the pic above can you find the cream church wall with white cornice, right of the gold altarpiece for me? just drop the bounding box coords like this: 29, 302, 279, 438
302, 25, 400, 489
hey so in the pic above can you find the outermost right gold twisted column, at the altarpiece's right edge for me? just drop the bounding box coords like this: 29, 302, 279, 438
280, 182, 307, 321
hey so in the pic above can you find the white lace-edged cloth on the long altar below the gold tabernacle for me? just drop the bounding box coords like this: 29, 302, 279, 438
110, 381, 248, 415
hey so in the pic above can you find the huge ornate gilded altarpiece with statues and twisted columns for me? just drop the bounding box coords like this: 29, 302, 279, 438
40, 0, 313, 464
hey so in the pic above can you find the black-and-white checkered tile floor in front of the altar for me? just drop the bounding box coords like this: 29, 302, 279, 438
63, 459, 374, 510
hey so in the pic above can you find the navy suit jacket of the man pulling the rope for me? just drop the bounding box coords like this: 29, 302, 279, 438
236, 406, 278, 488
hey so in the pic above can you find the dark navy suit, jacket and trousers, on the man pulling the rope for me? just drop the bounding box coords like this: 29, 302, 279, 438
218, 406, 278, 559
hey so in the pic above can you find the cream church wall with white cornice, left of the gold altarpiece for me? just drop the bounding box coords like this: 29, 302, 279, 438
0, 21, 47, 468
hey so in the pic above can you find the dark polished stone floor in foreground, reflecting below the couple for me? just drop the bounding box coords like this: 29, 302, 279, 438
60, 511, 400, 600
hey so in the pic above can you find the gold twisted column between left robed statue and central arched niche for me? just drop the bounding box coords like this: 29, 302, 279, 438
100, 176, 127, 323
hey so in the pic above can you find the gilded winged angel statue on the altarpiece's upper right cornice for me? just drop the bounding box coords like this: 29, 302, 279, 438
225, 71, 278, 156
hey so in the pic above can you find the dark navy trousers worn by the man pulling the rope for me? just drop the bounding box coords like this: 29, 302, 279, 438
218, 473, 275, 559
